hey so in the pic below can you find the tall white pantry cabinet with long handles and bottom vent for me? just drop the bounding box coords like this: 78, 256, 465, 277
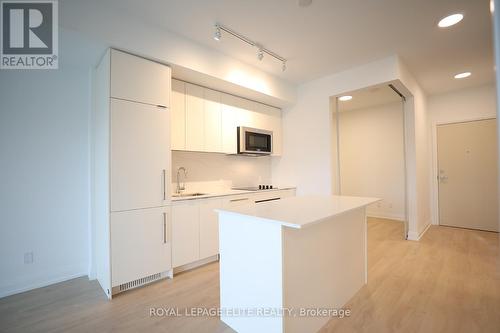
92, 49, 172, 298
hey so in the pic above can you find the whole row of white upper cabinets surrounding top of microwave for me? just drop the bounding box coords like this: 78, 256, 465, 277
172, 80, 282, 156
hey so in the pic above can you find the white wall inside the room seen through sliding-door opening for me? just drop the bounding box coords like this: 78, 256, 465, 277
339, 102, 405, 220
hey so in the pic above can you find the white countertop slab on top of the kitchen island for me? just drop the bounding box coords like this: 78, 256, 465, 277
216, 195, 381, 229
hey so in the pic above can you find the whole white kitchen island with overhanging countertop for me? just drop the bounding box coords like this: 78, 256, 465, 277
217, 196, 379, 333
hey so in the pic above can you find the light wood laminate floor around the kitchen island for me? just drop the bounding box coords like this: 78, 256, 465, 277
0, 219, 500, 333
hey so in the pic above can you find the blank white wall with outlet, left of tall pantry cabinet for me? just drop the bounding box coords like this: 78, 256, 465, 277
0, 64, 90, 297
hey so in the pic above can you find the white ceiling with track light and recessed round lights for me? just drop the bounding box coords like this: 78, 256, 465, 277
105, 0, 494, 94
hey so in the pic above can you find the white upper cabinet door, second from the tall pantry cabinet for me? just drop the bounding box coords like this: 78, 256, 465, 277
186, 83, 205, 151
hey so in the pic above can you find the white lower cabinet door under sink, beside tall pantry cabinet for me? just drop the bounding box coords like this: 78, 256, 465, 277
172, 200, 200, 267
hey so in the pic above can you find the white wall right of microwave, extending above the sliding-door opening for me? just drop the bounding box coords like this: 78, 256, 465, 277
273, 57, 398, 195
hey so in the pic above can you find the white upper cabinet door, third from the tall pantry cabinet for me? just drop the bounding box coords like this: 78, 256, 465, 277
204, 89, 222, 152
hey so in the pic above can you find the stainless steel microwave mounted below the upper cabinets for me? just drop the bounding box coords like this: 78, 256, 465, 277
238, 126, 273, 156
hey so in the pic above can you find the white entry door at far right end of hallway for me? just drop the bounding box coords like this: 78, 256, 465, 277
437, 119, 498, 231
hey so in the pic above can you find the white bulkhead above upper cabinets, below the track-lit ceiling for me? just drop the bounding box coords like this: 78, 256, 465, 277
59, 0, 296, 106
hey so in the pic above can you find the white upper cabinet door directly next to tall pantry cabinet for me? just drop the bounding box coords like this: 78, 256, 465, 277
170, 80, 186, 150
